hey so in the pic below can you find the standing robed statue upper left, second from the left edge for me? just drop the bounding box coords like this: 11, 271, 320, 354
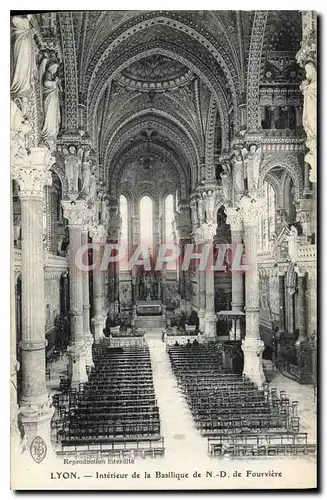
41, 61, 62, 148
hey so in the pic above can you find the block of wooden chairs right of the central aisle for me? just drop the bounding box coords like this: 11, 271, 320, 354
167, 344, 315, 456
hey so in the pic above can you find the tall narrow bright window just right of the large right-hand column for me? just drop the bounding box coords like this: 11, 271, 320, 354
258, 182, 276, 251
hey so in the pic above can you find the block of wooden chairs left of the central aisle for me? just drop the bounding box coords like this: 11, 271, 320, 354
53, 344, 164, 455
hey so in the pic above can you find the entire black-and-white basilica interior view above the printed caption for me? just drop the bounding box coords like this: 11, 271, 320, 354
10, 11, 319, 488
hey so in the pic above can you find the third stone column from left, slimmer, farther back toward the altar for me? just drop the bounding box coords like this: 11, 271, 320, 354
90, 225, 106, 343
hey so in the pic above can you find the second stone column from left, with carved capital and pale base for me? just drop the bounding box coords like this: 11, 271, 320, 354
61, 200, 91, 387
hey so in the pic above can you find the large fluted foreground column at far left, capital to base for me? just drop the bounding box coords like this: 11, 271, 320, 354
12, 148, 54, 450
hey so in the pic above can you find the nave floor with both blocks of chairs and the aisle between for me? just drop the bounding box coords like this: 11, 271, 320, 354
49, 328, 316, 465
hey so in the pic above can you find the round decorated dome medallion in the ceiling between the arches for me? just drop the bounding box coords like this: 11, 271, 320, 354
117, 54, 194, 92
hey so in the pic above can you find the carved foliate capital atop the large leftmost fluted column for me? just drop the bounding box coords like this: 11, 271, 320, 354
11, 148, 54, 199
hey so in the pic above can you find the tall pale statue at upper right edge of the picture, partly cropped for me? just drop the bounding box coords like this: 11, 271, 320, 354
300, 61, 317, 182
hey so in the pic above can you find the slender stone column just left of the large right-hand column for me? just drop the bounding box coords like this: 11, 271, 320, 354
225, 207, 244, 340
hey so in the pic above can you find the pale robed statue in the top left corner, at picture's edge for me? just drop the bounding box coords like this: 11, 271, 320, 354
10, 16, 37, 96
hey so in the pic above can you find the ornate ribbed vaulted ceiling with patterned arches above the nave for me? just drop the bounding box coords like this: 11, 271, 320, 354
35, 11, 300, 201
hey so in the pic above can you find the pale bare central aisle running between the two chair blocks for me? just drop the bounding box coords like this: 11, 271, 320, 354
146, 328, 208, 461
